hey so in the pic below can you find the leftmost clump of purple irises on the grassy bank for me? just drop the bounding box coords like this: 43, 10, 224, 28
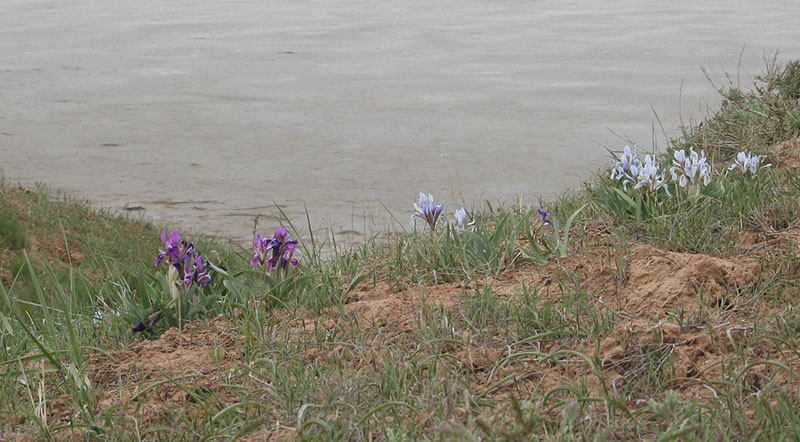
156, 230, 211, 290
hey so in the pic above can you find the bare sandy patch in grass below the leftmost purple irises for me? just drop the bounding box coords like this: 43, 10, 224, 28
88, 318, 240, 422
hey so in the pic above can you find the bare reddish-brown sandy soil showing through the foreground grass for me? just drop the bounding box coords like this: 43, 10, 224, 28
31, 238, 797, 439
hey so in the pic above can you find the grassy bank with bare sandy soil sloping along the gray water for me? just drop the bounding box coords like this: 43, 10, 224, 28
0, 59, 800, 440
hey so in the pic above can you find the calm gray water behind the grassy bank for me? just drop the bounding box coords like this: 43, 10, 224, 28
0, 0, 800, 240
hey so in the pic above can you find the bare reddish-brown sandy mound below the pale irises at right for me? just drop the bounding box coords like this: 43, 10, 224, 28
617, 245, 760, 318
